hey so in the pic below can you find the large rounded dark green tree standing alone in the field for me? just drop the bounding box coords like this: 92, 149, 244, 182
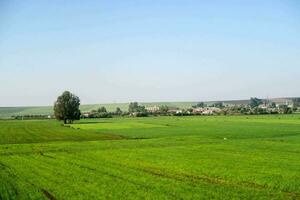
54, 91, 81, 124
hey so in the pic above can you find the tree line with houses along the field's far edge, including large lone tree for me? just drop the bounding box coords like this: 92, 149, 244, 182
54, 91, 300, 124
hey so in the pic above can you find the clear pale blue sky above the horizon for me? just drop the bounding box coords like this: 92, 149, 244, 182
0, 0, 300, 106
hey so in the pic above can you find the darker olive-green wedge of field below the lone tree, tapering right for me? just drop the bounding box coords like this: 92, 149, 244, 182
0, 120, 122, 144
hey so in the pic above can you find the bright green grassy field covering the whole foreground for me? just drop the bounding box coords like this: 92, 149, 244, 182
0, 115, 300, 200
